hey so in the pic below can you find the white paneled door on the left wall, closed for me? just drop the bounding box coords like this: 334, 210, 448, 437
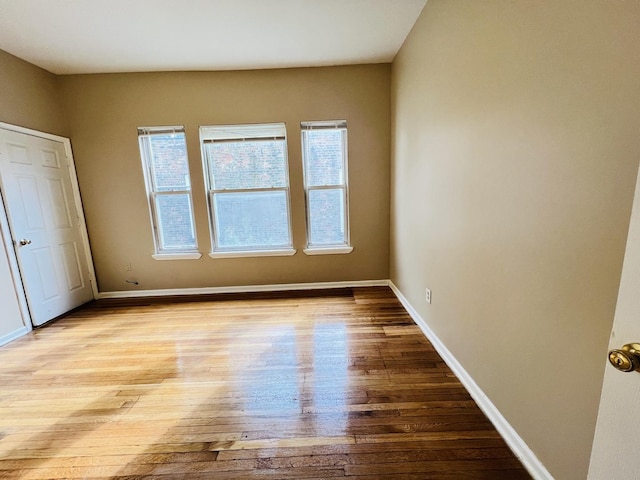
0, 129, 93, 325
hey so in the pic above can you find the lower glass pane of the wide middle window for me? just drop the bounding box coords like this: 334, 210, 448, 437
213, 191, 291, 249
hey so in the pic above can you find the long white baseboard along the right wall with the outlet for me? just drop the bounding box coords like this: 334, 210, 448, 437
388, 281, 553, 480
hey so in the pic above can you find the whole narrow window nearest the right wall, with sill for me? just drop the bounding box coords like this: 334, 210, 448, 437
300, 120, 353, 255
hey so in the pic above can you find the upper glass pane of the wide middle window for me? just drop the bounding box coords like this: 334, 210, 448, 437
205, 140, 287, 190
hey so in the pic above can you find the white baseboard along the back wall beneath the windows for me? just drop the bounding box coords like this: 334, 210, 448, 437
96, 280, 389, 300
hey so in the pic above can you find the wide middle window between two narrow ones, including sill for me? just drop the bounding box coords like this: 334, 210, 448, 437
200, 123, 295, 257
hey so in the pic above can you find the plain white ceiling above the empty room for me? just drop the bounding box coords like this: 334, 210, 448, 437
0, 0, 427, 74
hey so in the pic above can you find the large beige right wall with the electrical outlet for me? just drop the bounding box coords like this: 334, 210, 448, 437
391, 0, 640, 480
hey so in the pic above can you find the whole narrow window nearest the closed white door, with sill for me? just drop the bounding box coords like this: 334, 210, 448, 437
138, 127, 201, 260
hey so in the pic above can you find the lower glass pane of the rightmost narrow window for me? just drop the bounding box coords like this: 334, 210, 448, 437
308, 188, 346, 245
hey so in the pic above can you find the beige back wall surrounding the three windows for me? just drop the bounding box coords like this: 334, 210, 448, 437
59, 65, 391, 291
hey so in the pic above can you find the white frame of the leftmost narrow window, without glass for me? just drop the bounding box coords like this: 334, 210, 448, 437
138, 125, 202, 260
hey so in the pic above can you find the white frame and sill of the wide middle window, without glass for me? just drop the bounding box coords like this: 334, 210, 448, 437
200, 122, 296, 258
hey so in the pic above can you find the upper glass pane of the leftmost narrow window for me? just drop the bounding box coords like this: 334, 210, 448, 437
149, 133, 190, 192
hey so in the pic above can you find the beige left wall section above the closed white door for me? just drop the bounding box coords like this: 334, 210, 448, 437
0, 50, 69, 137
